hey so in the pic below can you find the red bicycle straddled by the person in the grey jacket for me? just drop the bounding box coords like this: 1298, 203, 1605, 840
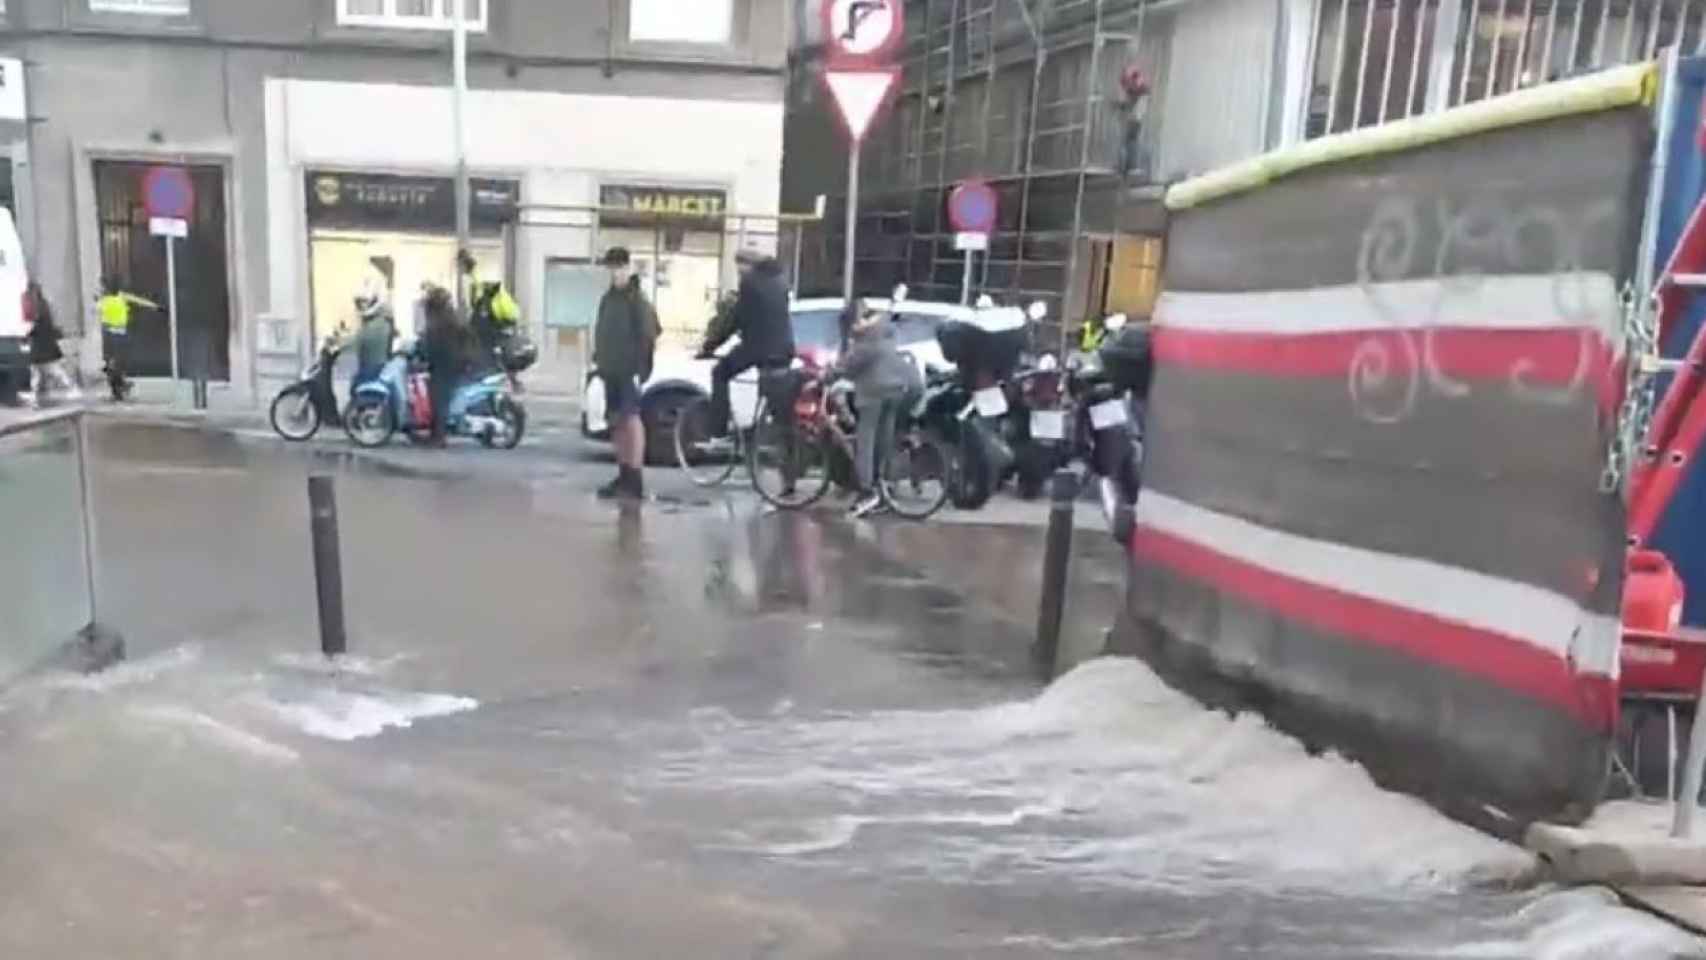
747, 370, 952, 520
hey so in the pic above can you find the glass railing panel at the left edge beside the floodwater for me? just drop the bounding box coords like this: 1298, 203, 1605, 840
0, 411, 102, 685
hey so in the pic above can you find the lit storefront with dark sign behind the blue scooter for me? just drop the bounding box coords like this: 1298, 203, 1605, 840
305, 171, 520, 341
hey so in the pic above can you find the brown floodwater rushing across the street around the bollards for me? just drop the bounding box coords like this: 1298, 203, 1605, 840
0, 426, 1706, 960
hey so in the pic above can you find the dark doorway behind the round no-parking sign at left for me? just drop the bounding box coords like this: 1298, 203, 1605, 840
94, 160, 230, 382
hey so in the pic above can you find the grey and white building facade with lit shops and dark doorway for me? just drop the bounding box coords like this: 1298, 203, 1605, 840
0, 0, 790, 399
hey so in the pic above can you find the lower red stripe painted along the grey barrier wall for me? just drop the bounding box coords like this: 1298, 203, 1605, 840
1131, 527, 1616, 732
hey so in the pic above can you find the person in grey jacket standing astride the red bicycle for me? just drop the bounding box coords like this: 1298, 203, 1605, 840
841, 310, 923, 517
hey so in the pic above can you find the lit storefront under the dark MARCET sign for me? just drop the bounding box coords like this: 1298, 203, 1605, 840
599, 184, 739, 350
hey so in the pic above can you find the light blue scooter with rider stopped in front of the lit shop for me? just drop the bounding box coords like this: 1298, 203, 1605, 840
343, 346, 527, 450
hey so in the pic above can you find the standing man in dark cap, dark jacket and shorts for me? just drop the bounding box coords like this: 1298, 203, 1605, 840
592, 247, 664, 500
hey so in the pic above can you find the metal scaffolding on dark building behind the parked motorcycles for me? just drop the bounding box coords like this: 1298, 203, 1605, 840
805, 0, 1160, 346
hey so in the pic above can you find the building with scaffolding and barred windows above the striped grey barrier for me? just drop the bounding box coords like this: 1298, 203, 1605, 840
783, 0, 1706, 344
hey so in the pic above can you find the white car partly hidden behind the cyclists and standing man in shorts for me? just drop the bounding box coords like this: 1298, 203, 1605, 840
580, 297, 971, 464
